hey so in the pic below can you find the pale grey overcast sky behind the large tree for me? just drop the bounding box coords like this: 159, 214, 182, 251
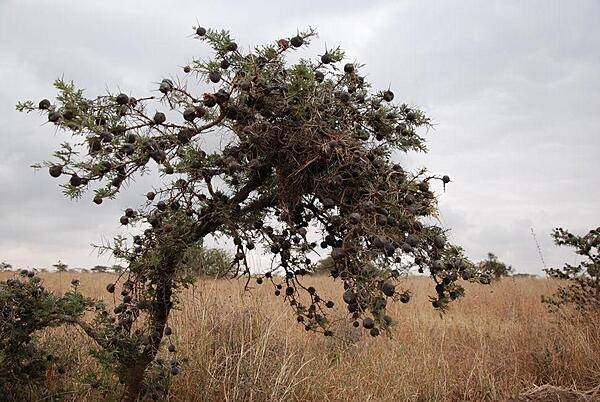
0, 0, 600, 273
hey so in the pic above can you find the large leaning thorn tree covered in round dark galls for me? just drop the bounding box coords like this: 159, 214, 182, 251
17, 27, 480, 400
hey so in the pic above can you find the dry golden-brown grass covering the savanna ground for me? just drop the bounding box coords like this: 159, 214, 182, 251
0, 273, 600, 401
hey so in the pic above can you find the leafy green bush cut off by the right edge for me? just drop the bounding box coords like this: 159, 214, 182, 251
542, 227, 600, 313
